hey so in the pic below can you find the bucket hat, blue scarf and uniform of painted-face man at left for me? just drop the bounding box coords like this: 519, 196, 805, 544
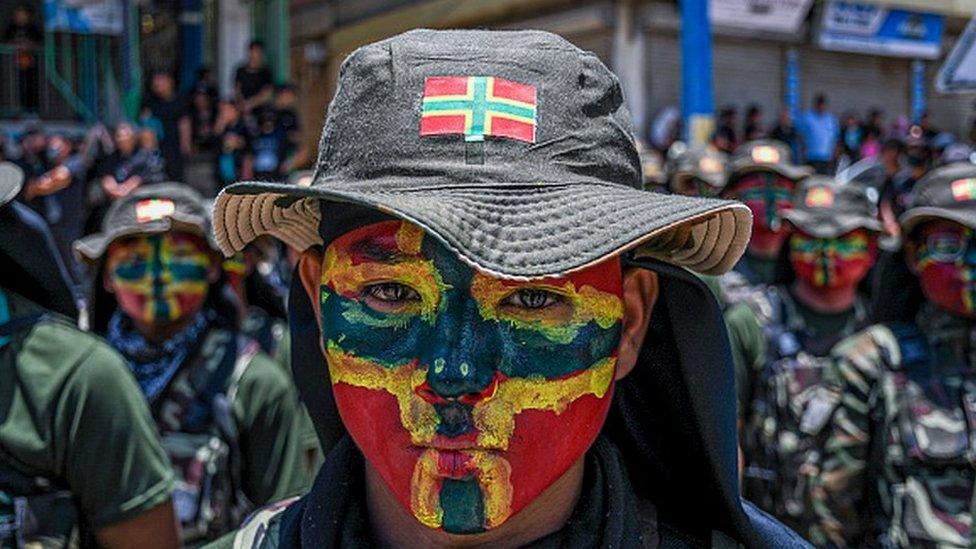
75, 183, 311, 544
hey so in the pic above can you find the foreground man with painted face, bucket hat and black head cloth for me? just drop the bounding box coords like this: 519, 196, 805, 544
208, 31, 798, 547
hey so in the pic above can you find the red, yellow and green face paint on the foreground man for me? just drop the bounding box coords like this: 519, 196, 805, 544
319, 221, 623, 534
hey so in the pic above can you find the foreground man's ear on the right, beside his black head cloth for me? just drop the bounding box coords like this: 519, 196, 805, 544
615, 268, 659, 380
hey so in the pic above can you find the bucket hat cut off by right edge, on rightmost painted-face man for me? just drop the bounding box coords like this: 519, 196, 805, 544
898, 162, 976, 235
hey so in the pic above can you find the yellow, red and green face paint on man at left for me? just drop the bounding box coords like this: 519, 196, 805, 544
105, 232, 211, 325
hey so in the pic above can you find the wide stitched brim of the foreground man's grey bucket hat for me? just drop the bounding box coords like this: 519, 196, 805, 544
214, 180, 752, 279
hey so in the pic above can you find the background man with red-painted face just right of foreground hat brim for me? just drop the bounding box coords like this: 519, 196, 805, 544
722, 140, 810, 285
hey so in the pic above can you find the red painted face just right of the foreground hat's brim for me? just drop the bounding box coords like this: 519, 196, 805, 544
727, 172, 795, 257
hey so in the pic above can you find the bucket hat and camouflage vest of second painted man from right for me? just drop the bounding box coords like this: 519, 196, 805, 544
739, 177, 881, 533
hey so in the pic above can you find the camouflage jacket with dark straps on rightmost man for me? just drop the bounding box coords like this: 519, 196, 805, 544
804, 306, 976, 547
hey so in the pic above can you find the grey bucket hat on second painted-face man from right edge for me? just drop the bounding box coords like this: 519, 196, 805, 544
783, 176, 884, 238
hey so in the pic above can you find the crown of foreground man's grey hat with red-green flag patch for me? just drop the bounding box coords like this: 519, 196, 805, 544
313, 30, 641, 189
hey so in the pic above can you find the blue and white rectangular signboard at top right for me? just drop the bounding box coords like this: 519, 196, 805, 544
818, 0, 944, 59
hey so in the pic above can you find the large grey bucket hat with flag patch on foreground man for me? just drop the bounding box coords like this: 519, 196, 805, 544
214, 30, 751, 278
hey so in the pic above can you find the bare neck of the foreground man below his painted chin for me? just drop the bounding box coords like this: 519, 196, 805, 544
366, 457, 583, 548
